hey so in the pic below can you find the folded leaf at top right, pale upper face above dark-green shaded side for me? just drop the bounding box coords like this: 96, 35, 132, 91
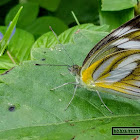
99, 0, 136, 31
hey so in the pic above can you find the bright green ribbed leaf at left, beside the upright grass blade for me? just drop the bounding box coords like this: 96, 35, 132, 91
8, 29, 34, 64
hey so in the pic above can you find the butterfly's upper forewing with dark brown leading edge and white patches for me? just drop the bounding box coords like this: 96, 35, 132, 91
82, 16, 140, 70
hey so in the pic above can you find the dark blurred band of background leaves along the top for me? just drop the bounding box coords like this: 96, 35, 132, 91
0, 0, 138, 38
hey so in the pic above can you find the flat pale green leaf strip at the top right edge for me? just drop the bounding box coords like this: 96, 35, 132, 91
102, 0, 137, 11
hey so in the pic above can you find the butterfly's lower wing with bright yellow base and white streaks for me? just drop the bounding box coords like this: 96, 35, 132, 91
82, 50, 140, 97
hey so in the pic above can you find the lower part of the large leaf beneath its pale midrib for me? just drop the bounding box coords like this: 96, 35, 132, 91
0, 115, 140, 140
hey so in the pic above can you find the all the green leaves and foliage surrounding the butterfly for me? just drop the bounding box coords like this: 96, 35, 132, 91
0, 0, 140, 140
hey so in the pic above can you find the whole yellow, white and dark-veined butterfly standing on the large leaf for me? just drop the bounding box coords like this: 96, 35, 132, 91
35, 16, 140, 112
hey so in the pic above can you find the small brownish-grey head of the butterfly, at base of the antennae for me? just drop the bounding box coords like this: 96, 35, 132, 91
68, 65, 81, 76
